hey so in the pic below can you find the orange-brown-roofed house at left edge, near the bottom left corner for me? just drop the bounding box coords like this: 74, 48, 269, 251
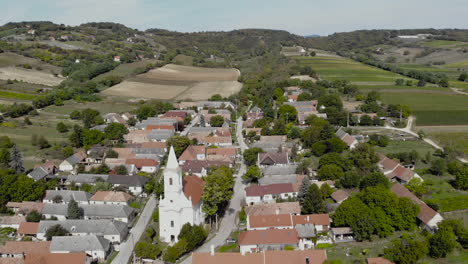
0, 241, 51, 263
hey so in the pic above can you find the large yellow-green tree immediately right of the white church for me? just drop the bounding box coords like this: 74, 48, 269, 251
202, 167, 234, 217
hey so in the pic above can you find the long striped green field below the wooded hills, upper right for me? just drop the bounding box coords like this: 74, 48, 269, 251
294, 56, 408, 85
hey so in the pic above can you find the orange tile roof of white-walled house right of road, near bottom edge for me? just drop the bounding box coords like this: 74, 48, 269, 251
239, 229, 299, 246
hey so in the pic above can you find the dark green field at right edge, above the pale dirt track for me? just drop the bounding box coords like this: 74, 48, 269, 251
382, 91, 468, 126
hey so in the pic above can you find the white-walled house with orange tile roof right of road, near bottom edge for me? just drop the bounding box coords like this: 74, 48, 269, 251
239, 229, 299, 254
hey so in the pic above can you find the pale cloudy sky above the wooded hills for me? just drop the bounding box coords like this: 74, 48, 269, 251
0, 0, 468, 35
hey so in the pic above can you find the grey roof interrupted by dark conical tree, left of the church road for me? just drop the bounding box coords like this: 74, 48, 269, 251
42, 203, 134, 218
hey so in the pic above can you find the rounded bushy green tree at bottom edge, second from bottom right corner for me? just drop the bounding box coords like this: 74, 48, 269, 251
384, 234, 428, 264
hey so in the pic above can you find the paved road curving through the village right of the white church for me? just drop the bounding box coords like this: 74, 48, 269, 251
180, 118, 248, 264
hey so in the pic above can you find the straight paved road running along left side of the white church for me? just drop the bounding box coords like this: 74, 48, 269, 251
112, 195, 156, 264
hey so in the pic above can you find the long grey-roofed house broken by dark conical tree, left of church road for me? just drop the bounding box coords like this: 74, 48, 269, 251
42, 204, 135, 223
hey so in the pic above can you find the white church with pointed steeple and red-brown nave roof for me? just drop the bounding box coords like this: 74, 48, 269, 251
159, 147, 205, 244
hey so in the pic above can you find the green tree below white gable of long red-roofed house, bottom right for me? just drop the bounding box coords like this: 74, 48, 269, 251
429, 226, 457, 258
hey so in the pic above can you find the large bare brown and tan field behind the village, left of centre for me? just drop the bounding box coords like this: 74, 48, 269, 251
102, 64, 242, 100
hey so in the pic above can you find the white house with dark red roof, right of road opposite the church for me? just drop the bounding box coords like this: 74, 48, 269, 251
245, 183, 297, 205
